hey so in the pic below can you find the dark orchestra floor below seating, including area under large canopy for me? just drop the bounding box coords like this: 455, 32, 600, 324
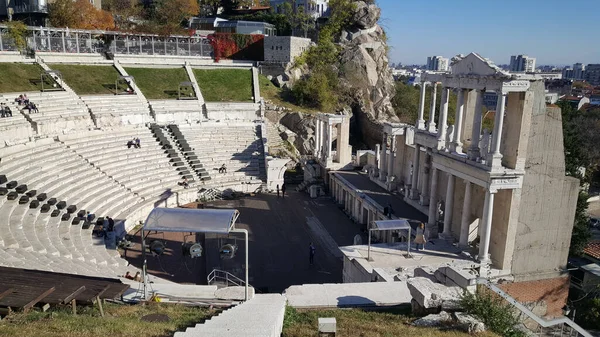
126, 187, 363, 292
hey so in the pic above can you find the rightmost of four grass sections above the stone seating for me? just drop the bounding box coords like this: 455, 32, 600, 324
193, 69, 253, 102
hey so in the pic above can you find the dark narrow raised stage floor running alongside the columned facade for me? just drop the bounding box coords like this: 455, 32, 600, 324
336, 171, 427, 222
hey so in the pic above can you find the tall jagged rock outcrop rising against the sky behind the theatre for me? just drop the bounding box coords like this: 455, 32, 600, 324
339, 1, 398, 146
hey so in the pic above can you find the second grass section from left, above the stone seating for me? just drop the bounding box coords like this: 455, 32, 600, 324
49, 64, 120, 95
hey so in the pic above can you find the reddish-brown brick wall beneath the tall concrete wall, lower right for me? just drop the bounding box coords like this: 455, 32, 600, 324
498, 276, 569, 319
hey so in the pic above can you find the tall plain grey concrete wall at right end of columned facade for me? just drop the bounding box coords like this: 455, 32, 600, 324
512, 82, 579, 281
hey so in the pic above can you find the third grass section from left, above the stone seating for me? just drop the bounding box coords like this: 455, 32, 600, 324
125, 68, 190, 99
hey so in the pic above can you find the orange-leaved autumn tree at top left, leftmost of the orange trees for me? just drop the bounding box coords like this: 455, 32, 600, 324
49, 0, 115, 30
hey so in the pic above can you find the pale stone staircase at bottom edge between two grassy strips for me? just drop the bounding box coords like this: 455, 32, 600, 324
174, 294, 286, 337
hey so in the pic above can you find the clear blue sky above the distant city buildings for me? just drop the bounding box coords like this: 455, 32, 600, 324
377, 0, 600, 66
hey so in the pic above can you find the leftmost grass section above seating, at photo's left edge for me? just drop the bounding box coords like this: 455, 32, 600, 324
0, 63, 44, 92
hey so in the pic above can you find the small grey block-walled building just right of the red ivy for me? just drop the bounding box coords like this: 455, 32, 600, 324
265, 36, 312, 63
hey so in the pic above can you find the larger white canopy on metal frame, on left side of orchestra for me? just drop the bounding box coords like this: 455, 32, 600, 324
142, 208, 248, 301
